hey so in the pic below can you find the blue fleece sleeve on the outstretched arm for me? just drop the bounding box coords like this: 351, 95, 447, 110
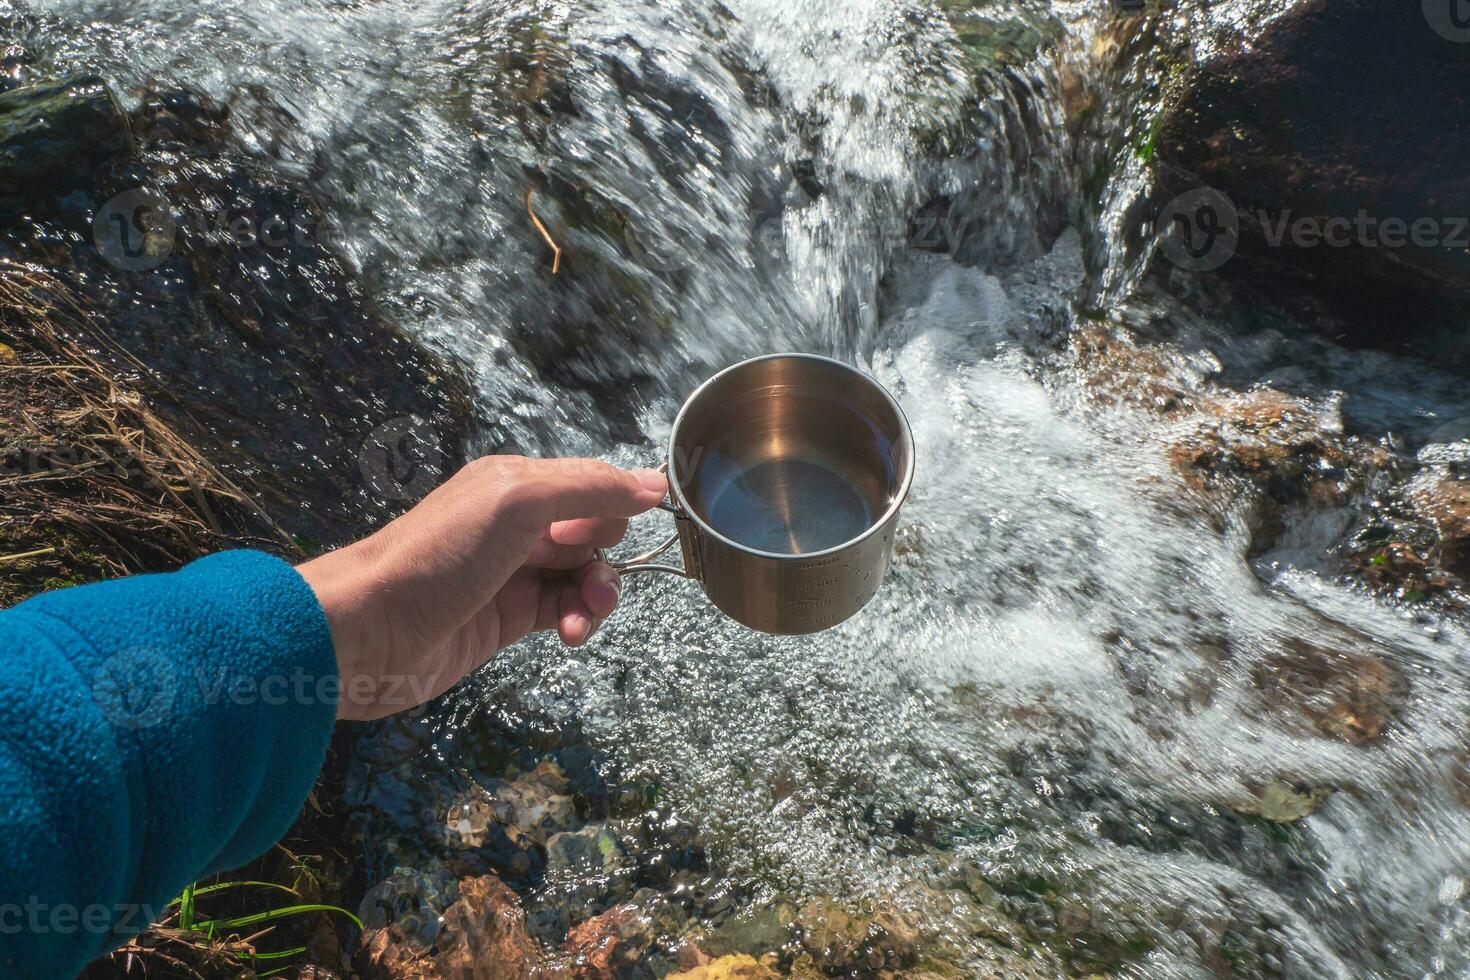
0, 551, 337, 979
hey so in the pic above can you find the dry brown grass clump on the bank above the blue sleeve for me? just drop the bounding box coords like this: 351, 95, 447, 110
0, 260, 297, 605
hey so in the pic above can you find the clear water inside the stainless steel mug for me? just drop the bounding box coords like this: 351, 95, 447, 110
685, 385, 900, 554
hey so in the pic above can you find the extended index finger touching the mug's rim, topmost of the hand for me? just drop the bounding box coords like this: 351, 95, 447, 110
510, 460, 669, 526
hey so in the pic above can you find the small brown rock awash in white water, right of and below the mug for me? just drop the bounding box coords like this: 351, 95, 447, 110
1251, 639, 1405, 745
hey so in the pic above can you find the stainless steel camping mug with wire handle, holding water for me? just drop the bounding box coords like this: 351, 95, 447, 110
596, 354, 914, 633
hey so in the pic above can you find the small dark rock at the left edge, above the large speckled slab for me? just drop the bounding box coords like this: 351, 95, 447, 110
0, 75, 129, 217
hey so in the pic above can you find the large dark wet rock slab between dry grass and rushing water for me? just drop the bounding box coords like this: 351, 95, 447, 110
0, 82, 473, 551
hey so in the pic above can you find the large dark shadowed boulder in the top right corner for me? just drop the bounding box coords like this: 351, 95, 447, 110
1154, 0, 1470, 364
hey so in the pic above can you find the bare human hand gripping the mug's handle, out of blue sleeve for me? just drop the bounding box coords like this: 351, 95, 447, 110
297, 455, 667, 721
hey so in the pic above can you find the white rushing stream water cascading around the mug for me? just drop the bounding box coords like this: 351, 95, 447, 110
20, 0, 1470, 977
